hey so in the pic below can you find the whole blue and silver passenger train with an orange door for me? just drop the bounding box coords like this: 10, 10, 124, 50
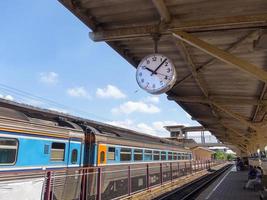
0, 100, 192, 200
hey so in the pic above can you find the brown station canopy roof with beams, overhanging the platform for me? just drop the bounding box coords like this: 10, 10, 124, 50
60, 0, 267, 152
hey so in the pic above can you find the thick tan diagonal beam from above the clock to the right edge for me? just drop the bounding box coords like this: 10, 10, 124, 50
173, 31, 267, 82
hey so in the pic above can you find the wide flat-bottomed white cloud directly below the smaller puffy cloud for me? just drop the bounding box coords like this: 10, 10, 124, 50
111, 101, 160, 114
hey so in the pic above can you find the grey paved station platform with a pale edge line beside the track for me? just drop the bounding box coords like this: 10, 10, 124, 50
197, 166, 260, 200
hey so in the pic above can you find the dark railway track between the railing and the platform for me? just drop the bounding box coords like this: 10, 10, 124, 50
154, 164, 233, 200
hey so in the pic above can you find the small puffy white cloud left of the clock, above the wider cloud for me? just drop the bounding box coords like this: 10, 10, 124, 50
96, 85, 126, 99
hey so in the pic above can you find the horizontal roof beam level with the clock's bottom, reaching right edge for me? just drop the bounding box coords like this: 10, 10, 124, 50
167, 96, 267, 106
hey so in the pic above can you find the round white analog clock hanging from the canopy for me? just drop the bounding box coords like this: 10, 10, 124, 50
136, 54, 176, 94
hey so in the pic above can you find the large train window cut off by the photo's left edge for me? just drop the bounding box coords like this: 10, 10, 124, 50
0, 138, 18, 165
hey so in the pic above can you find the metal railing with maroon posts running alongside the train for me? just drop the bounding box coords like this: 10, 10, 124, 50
41, 161, 221, 200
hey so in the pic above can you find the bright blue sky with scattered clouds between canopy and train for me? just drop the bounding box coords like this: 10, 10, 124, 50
0, 0, 201, 136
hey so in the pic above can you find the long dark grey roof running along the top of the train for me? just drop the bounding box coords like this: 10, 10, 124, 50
0, 98, 186, 148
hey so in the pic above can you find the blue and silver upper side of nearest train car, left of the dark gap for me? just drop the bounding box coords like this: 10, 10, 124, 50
0, 108, 84, 172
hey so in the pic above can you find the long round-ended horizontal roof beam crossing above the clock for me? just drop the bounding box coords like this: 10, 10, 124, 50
89, 13, 267, 42
